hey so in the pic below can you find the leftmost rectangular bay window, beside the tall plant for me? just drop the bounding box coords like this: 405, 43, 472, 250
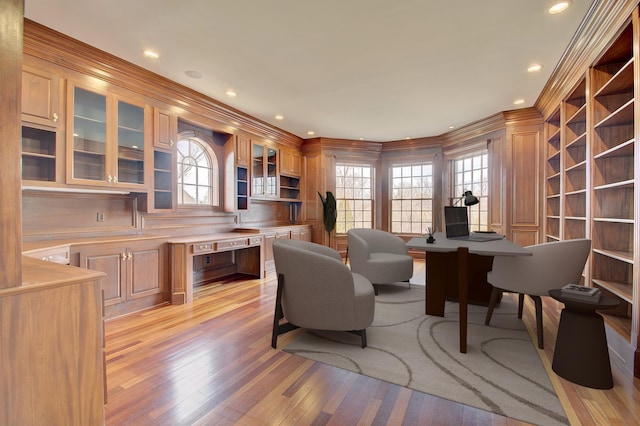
336, 164, 374, 234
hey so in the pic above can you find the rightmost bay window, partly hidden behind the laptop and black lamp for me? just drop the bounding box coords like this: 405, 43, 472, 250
452, 151, 489, 231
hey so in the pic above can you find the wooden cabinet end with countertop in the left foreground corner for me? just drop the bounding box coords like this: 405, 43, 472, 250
0, 257, 106, 425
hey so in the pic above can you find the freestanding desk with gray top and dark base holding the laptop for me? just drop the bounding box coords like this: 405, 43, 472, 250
407, 232, 531, 353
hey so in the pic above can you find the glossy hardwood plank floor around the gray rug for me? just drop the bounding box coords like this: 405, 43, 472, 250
105, 262, 640, 425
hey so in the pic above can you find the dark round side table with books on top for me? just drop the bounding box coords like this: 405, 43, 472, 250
549, 289, 620, 389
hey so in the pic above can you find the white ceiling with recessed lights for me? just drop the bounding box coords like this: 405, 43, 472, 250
25, 0, 592, 141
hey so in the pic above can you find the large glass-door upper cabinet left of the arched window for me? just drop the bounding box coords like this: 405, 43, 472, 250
67, 85, 153, 190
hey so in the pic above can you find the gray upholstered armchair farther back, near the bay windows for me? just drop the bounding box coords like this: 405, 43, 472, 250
347, 228, 413, 294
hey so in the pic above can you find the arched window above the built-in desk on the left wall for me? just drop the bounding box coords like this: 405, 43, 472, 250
177, 138, 220, 206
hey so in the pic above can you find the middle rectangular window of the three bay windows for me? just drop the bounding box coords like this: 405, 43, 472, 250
391, 163, 433, 235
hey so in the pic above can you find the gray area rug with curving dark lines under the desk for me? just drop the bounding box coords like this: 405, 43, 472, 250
284, 283, 568, 425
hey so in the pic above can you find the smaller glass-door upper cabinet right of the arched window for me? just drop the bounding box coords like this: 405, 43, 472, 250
251, 143, 278, 197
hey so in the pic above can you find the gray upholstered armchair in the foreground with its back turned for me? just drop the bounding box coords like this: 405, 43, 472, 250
271, 239, 375, 349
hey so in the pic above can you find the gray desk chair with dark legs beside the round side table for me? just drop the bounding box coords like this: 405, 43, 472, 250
484, 239, 591, 349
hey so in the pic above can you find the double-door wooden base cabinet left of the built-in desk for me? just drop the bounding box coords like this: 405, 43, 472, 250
78, 240, 169, 318
